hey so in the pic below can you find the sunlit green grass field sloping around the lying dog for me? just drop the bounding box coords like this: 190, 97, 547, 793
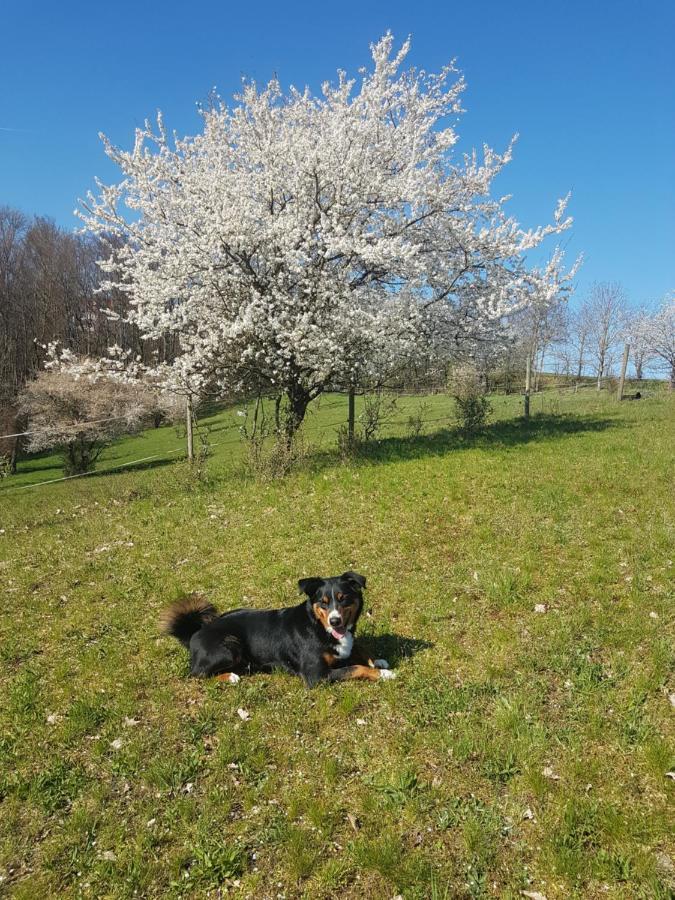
0, 391, 675, 900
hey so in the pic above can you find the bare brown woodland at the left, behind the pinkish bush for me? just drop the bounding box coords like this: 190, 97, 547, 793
0, 206, 180, 466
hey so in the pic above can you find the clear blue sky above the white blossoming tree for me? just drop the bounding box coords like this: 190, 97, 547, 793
0, 0, 675, 304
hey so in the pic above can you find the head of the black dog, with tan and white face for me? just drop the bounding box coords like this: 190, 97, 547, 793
298, 572, 366, 641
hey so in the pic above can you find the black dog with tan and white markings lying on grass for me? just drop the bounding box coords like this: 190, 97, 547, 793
161, 572, 395, 686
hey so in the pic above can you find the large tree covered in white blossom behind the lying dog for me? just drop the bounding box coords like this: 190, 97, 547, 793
81, 34, 571, 436
